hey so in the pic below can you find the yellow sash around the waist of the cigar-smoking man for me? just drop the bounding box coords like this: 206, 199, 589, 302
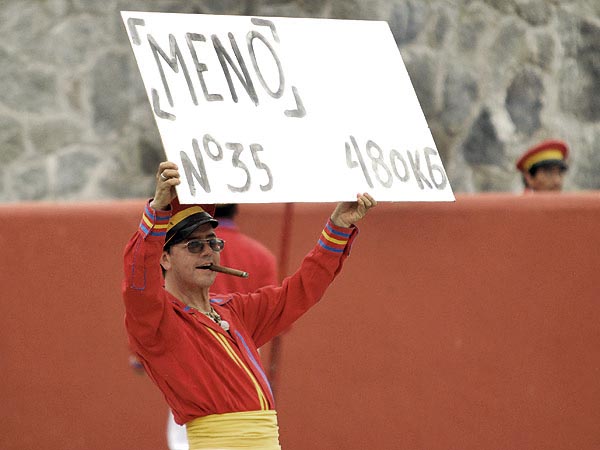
185, 410, 281, 450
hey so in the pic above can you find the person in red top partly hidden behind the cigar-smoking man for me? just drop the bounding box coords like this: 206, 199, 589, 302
167, 203, 279, 450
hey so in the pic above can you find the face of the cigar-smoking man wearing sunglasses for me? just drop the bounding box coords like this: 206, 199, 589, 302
161, 224, 221, 290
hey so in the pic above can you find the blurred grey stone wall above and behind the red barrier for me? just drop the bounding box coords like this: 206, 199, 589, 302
0, 0, 600, 202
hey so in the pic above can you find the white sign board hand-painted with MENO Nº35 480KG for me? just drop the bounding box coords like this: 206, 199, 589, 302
121, 12, 454, 203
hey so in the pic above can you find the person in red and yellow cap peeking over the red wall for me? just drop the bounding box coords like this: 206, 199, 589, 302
516, 140, 569, 192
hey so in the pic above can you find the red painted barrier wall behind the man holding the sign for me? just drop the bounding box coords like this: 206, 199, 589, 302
0, 193, 600, 450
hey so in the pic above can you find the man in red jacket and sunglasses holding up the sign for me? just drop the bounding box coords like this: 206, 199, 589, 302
123, 162, 377, 450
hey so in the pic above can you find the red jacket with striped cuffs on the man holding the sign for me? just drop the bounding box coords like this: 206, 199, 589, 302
123, 205, 358, 424
